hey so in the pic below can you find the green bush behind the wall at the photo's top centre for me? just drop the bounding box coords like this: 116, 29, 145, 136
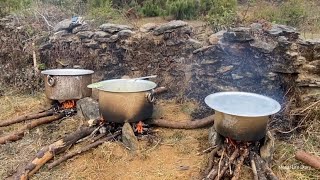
166, 0, 199, 19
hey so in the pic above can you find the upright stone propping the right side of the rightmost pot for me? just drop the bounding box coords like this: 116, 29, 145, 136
260, 131, 275, 164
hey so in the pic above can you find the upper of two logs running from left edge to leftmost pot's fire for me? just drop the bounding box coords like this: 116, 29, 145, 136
0, 110, 53, 127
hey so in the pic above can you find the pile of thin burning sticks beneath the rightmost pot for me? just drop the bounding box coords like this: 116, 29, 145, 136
204, 133, 278, 180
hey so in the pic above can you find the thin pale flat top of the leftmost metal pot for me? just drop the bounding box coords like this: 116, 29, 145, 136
41, 69, 94, 76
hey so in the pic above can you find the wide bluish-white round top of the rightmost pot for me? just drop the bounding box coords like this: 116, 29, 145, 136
205, 92, 281, 117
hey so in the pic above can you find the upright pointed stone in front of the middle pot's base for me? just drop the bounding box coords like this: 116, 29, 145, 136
122, 122, 139, 151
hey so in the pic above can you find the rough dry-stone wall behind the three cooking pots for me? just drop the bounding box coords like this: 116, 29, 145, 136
0, 17, 320, 118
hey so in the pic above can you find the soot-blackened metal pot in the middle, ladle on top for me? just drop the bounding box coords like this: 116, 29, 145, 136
97, 79, 157, 123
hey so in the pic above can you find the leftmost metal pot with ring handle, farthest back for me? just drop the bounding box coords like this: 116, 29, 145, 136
41, 69, 94, 101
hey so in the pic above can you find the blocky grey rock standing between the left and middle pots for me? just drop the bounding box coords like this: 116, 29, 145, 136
77, 97, 100, 120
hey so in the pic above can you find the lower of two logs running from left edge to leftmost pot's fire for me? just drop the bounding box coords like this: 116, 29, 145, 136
0, 114, 64, 144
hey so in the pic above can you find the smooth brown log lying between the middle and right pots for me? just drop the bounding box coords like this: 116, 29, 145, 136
149, 116, 214, 129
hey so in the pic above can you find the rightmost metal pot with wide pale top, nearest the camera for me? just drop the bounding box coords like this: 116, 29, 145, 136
205, 92, 281, 141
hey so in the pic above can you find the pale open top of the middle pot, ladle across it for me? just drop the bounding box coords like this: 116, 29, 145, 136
97, 79, 157, 93
